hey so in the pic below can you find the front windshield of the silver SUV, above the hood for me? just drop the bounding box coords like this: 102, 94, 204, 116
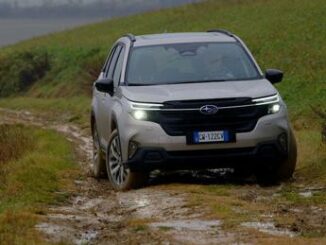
127, 43, 260, 85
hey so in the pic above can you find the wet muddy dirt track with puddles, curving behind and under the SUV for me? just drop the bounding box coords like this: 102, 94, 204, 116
0, 109, 326, 244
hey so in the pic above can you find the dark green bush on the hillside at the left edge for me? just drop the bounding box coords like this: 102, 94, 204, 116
0, 50, 50, 96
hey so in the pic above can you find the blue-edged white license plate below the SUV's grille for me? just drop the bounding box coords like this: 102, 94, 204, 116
193, 131, 230, 144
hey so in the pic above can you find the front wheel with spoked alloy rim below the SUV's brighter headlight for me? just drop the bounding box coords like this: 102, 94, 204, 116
106, 129, 148, 191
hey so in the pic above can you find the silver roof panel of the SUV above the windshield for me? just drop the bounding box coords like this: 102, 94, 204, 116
122, 32, 236, 47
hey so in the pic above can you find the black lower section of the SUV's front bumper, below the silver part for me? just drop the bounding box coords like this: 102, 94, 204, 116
126, 141, 287, 171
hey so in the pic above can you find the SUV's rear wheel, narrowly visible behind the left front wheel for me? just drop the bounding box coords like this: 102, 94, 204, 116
92, 123, 106, 178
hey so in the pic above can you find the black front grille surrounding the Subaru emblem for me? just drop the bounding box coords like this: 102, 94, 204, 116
148, 98, 268, 136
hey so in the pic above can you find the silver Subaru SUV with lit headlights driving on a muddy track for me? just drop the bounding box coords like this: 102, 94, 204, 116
91, 30, 297, 190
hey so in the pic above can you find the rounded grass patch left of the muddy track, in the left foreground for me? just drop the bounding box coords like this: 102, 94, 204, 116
0, 125, 77, 244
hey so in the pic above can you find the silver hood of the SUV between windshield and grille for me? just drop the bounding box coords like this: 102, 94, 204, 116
121, 79, 277, 103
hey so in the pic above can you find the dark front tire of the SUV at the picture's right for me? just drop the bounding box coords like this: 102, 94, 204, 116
256, 129, 297, 185
